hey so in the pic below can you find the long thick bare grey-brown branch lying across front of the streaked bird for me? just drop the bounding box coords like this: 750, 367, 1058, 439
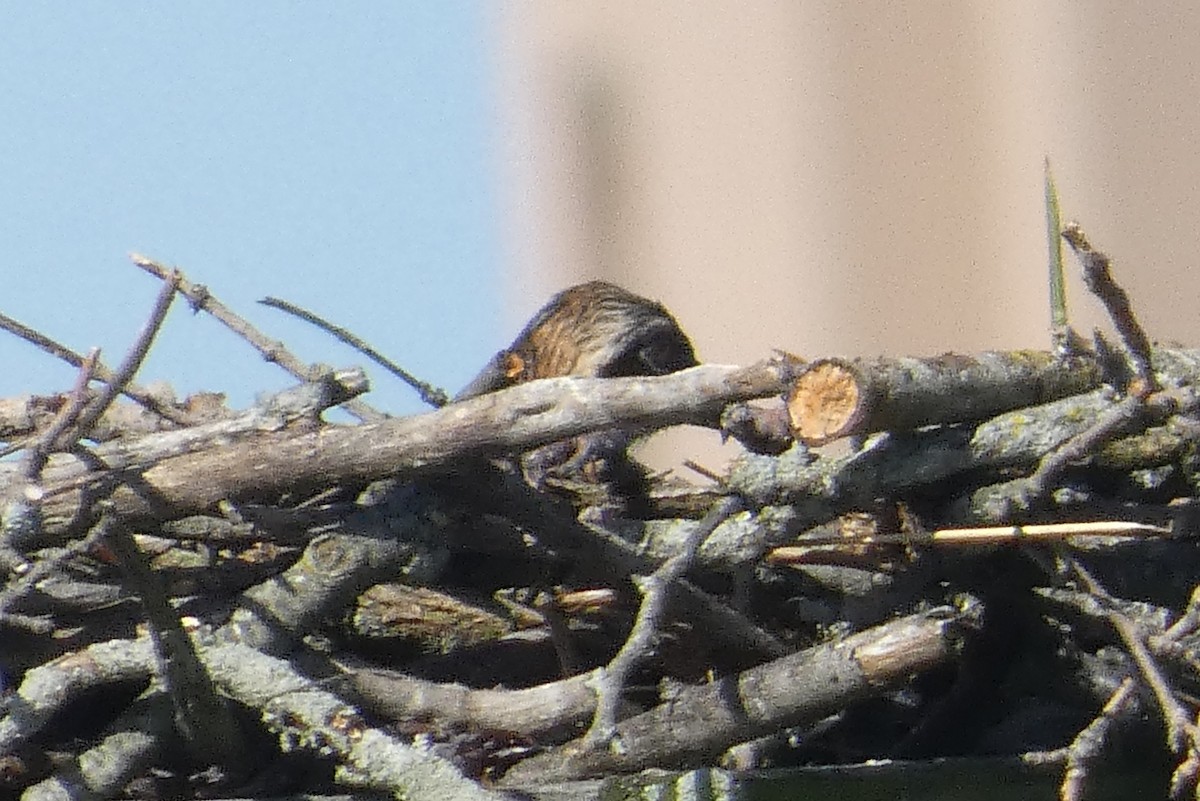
23, 363, 781, 534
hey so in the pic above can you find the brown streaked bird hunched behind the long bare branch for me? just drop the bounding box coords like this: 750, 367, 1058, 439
454, 281, 698, 511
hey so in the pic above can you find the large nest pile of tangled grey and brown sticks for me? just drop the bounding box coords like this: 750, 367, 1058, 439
0, 228, 1200, 800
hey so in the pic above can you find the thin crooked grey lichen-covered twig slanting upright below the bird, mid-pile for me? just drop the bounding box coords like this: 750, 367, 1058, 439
584, 496, 743, 748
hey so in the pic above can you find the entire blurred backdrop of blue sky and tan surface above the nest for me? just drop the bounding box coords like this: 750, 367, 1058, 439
0, 0, 1200, 470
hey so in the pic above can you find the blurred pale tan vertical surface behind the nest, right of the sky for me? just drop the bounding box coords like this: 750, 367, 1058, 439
484, 0, 1200, 470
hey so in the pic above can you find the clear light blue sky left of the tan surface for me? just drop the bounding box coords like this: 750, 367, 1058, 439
0, 2, 503, 414
